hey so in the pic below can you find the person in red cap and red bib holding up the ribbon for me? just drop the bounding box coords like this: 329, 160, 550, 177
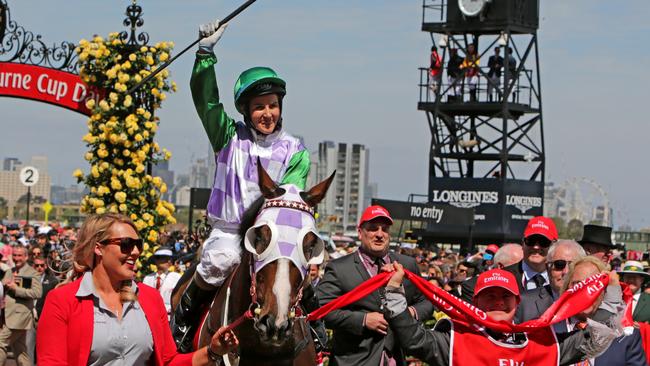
385, 263, 616, 366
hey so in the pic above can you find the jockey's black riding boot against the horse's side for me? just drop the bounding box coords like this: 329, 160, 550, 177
170, 278, 216, 353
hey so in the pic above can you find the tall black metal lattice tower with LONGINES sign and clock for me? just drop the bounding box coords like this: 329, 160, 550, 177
418, 0, 545, 244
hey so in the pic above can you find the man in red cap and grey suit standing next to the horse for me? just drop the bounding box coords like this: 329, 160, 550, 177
317, 206, 433, 366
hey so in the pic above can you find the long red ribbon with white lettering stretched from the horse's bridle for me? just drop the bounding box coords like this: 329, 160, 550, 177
307, 270, 609, 333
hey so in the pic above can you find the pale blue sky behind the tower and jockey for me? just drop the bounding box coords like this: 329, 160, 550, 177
0, 0, 650, 228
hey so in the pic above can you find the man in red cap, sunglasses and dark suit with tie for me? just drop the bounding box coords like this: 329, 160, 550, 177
461, 216, 558, 302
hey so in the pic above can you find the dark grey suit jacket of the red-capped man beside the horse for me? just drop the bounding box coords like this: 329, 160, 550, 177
317, 252, 433, 366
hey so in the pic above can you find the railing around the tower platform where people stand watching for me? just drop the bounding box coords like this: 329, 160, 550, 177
418, 67, 536, 107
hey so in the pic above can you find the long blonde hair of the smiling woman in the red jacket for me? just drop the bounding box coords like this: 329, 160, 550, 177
72, 213, 138, 303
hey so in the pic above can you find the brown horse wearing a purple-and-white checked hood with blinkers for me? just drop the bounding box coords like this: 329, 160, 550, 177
172, 161, 335, 366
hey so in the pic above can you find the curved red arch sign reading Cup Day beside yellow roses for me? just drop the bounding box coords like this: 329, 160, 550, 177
0, 62, 100, 115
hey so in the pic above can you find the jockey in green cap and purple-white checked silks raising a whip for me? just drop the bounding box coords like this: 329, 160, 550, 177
171, 21, 310, 352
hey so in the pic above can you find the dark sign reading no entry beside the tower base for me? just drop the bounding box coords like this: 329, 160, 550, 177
372, 199, 474, 226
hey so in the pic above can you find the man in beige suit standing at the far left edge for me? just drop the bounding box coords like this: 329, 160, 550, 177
0, 245, 43, 366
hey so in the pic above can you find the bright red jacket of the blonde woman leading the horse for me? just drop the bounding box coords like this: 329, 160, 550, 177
36, 278, 193, 366
